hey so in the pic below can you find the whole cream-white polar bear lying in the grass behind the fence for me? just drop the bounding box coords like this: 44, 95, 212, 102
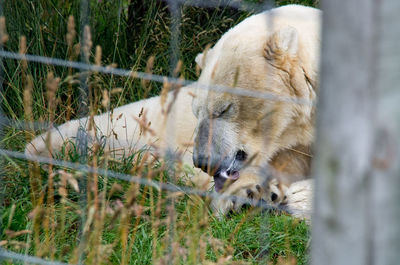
25, 5, 321, 219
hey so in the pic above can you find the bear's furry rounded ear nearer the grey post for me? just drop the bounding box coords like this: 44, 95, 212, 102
265, 26, 299, 59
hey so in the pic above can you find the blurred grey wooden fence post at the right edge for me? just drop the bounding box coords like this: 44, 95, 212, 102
311, 0, 400, 265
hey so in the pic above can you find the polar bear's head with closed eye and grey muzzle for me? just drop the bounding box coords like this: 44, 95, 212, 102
192, 8, 319, 191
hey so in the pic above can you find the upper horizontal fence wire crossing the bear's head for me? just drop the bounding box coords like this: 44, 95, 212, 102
0, 51, 314, 105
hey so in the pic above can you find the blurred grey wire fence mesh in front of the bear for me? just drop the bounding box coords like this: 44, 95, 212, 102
0, 0, 315, 265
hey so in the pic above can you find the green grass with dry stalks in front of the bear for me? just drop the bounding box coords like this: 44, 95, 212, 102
2, 148, 309, 264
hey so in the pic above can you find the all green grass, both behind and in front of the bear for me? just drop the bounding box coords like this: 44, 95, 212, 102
0, 0, 317, 264
